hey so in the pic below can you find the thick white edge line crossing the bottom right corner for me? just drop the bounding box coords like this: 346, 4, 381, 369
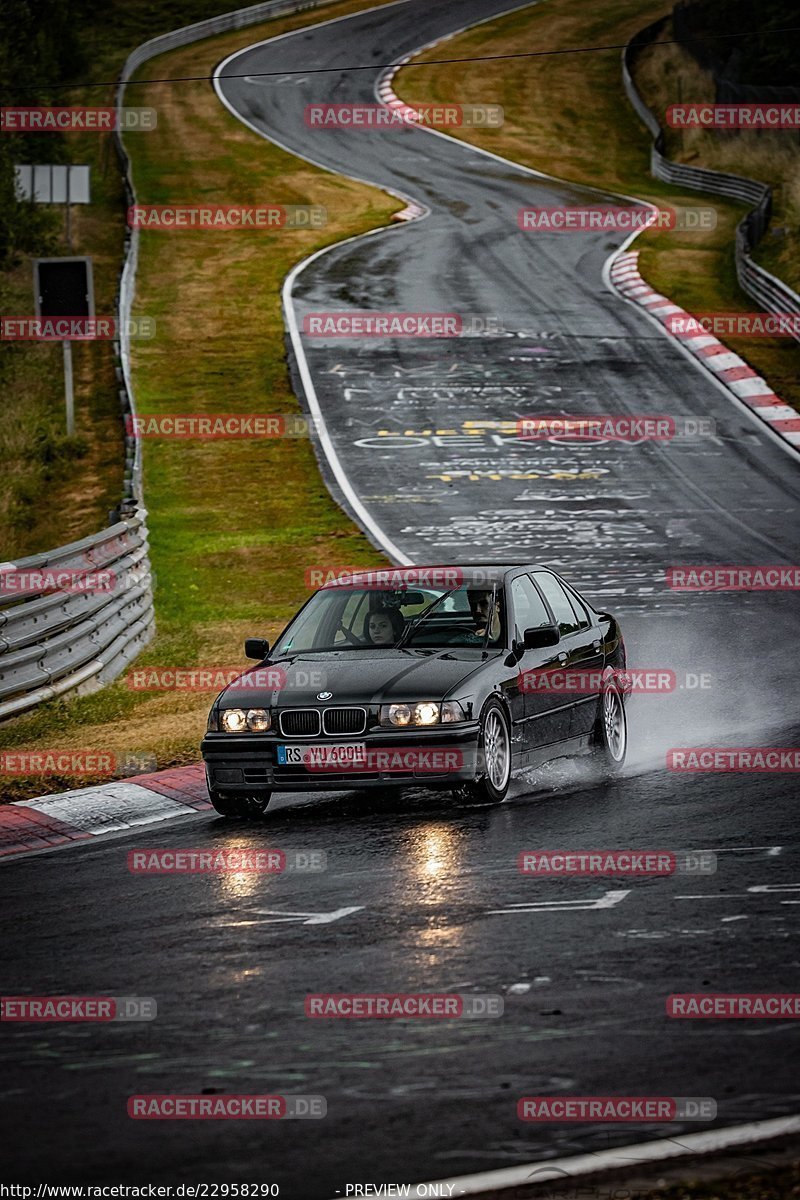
388, 1115, 800, 1200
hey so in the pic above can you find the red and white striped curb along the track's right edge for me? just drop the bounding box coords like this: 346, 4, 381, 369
609, 250, 800, 450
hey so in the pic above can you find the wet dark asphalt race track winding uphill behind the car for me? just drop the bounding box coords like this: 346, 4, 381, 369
0, 0, 800, 1198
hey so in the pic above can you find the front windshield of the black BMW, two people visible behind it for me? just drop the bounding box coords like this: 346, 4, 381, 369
275, 584, 503, 654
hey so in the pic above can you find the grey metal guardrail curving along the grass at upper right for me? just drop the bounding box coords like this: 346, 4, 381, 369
622, 17, 800, 341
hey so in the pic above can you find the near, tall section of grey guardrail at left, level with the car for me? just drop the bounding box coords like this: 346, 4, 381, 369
0, 512, 154, 719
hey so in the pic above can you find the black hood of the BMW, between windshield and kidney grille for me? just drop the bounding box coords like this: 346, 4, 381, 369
219, 647, 500, 708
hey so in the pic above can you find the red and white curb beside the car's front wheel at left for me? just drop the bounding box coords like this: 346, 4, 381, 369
0, 763, 211, 860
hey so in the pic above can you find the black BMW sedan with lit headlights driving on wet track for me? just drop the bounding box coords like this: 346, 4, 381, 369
201, 565, 627, 817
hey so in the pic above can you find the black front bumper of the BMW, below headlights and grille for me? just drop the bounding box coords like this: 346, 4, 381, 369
200, 721, 480, 796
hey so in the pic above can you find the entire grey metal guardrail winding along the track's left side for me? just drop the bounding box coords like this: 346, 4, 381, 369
0, 0, 345, 720
